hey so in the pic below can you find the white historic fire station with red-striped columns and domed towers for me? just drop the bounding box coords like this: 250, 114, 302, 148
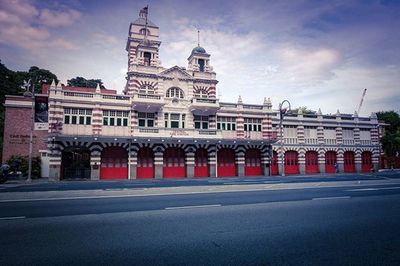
3, 9, 379, 180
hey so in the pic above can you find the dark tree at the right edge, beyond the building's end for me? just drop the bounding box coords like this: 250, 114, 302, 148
376, 111, 400, 156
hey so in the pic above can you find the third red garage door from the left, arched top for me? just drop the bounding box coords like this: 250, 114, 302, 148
163, 148, 186, 178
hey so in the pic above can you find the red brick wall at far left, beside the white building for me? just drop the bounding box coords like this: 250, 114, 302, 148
3, 107, 48, 161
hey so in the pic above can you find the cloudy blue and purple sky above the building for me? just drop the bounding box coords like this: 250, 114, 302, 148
0, 0, 400, 116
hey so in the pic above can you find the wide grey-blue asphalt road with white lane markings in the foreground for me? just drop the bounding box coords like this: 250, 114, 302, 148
0, 175, 400, 265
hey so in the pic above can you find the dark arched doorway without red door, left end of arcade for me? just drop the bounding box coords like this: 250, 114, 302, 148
61, 147, 90, 179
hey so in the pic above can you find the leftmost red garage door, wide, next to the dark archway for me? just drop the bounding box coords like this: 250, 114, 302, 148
100, 147, 128, 179
